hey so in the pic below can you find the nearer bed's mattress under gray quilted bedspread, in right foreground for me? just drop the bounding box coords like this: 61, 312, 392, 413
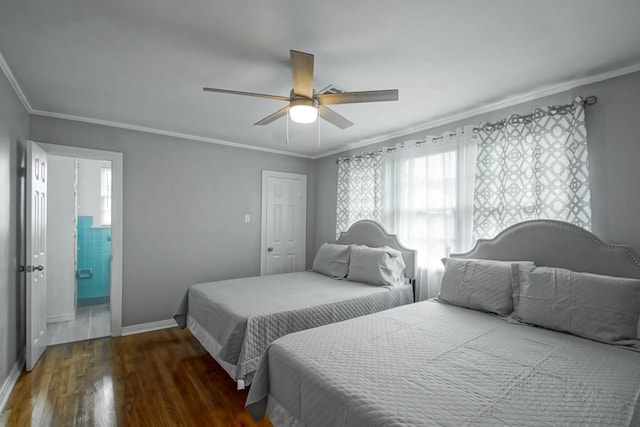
246, 301, 640, 426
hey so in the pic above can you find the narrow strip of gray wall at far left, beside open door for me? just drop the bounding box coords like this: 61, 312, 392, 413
0, 73, 29, 386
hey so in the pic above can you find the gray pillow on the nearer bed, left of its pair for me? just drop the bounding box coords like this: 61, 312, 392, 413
438, 258, 533, 316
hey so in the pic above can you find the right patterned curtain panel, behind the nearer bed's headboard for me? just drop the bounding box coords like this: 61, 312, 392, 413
473, 98, 591, 238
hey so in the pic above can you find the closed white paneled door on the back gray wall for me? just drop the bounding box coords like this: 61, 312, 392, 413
260, 171, 307, 275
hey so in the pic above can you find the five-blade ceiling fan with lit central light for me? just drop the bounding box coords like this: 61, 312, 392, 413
203, 50, 398, 129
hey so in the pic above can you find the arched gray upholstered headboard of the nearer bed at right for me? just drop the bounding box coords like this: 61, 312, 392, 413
451, 220, 640, 279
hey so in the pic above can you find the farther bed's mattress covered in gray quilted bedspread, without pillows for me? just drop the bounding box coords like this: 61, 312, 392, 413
178, 272, 413, 385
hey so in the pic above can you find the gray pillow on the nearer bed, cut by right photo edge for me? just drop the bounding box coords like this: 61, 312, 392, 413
513, 267, 640, 344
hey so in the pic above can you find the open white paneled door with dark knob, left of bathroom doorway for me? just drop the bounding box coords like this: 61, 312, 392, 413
25, 141, 49, 371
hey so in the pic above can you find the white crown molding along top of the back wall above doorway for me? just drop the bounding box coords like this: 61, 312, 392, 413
30, 110, 312, 159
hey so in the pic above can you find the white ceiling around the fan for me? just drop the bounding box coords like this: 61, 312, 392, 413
0, 0, 640, 156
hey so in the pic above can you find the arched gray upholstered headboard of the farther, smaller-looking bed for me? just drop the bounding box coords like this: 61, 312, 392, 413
336, 219, 417, 279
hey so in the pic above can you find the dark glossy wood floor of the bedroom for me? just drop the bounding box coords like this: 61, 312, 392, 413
0, 328, 270, 426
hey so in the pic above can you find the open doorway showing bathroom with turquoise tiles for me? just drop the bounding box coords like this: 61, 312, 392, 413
47, 155, 112, 345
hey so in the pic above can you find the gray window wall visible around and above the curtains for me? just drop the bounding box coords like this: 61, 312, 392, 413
315, 72, 640, 254
